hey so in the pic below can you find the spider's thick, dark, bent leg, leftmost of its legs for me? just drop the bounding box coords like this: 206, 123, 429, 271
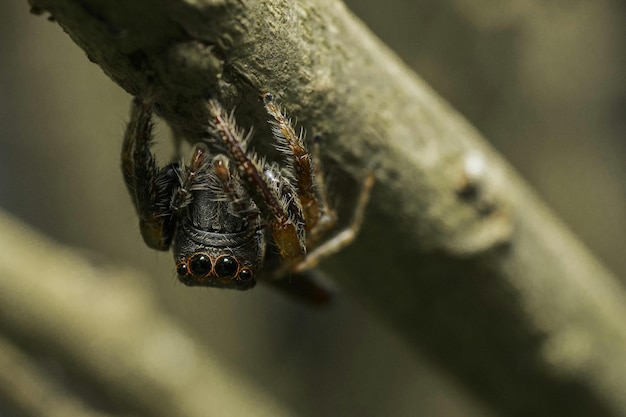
121, 98, 178, 250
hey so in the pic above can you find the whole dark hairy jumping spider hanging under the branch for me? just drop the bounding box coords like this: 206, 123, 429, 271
122, 93, 374, 300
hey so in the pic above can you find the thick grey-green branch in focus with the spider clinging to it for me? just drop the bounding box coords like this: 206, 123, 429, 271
22, 0, 626, 416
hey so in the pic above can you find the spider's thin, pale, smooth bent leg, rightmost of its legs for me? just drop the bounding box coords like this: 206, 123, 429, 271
290, 171, 375, 272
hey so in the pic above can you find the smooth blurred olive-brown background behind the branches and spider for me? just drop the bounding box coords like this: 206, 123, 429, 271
0, 0, 626, 417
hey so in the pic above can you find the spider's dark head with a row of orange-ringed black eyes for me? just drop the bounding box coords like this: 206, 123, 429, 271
173, 223, 265, 290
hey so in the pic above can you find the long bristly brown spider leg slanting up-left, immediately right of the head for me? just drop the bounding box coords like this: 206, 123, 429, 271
208, 100, 306, 265
